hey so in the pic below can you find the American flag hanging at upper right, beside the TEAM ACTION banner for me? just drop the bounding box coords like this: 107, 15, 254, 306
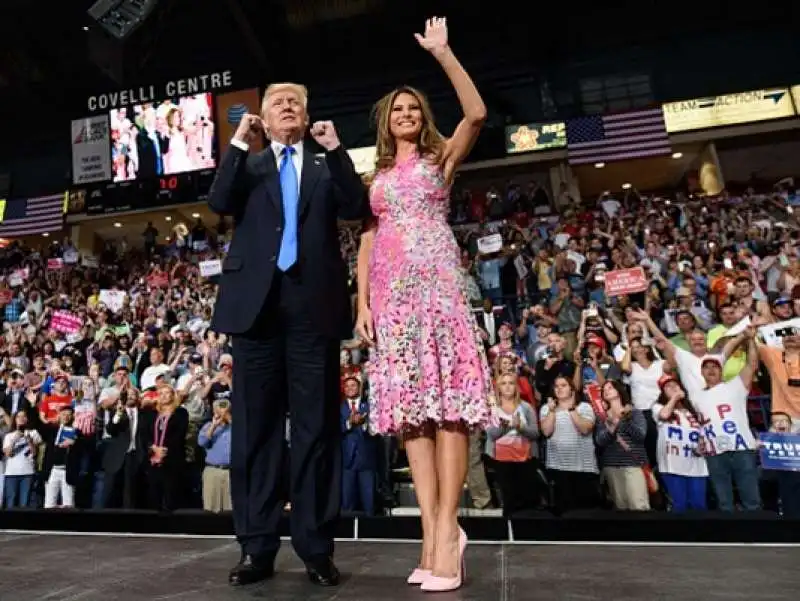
567, 108, 672, 165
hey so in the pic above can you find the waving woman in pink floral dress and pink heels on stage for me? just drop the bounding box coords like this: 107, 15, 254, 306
356, 18, 494, 591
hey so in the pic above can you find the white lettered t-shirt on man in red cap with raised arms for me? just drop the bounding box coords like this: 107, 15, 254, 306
689, 376, 758, 455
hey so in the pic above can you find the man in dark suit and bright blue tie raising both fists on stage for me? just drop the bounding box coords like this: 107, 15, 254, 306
209, 84, 366, 586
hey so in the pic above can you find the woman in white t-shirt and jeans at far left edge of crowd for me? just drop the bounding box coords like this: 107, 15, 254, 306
3, 411, 42, 509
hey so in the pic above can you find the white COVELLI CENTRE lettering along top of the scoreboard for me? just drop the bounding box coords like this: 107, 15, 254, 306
86, 70, 233, 113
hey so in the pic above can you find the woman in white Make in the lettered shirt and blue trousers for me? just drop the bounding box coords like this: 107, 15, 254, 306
653, 375, 708, 512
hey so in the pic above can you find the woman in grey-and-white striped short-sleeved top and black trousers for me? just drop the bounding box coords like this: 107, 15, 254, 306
540, 376, 600, 513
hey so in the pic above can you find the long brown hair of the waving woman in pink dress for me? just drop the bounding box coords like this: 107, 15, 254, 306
372, 86, 445, 171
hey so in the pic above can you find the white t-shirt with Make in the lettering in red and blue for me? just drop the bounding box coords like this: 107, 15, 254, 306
653, 403, 708, 478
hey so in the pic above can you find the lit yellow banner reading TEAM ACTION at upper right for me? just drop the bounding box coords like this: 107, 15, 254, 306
662, 88, 795, 133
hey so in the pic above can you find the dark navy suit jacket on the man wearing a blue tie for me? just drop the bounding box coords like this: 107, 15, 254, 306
208, 145, 367, 339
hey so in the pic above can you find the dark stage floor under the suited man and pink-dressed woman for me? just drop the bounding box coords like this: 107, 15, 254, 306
0, 534, 798, 601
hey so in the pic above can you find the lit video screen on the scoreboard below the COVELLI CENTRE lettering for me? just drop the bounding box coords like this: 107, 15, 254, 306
110, 93, 217, 182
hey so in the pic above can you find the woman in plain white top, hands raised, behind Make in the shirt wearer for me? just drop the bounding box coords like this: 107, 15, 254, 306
621, 336, 664, 465
